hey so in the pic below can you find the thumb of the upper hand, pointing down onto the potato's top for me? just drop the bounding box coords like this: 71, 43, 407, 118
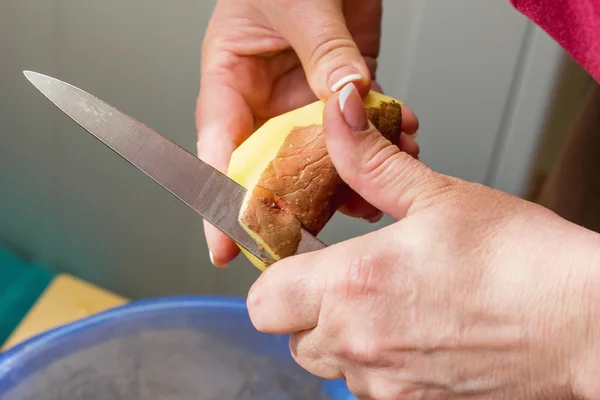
265, 0, 371, 100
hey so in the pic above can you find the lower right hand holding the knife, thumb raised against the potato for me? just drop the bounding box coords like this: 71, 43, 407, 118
248, 85, 600, 400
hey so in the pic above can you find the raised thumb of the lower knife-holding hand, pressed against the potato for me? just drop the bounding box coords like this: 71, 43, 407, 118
323, 84, 452, 219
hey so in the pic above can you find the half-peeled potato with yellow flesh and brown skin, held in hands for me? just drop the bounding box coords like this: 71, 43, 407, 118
227, 91, 402, 271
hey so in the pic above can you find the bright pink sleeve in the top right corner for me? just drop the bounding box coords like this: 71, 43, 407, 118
510, 0, 600, 82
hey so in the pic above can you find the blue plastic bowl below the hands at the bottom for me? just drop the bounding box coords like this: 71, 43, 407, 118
0, 296, 355, 400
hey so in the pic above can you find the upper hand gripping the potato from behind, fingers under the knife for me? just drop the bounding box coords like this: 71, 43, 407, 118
196, 0, 419, 266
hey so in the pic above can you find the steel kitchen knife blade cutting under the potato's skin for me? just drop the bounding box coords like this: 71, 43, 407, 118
23, 71, 326, 265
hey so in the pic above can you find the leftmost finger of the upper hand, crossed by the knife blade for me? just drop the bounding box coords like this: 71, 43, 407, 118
196, 76, 253, 267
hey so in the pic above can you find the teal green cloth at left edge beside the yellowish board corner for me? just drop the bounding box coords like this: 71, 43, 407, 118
0, 248, 56, 345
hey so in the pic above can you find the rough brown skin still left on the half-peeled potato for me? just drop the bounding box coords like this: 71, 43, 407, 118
240, 102, 402, 259
